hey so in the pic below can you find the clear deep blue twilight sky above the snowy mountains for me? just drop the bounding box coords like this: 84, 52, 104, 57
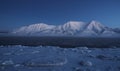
0, 0, 120, 30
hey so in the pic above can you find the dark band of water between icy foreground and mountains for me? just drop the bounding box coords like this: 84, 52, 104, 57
0, 36, 120, 48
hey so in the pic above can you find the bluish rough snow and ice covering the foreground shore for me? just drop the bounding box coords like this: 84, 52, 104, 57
0, 45, 120, 71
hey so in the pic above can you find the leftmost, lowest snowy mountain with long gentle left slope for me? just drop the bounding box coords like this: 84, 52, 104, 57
13, 23, 55, 34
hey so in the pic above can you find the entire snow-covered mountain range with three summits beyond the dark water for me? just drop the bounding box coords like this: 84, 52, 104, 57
12, 21, 119, 36
